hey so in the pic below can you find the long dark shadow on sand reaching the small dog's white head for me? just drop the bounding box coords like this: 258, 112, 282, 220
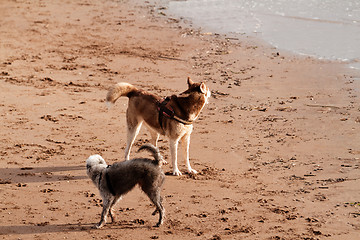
0, 165, 88, 184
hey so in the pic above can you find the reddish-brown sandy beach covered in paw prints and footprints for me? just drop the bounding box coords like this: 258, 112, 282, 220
0, 0, 360, 240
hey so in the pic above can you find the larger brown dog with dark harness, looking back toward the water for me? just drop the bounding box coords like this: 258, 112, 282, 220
106, 78, 211, 175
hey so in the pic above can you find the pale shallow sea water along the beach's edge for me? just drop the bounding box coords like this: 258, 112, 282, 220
167, 0, 360, 69
